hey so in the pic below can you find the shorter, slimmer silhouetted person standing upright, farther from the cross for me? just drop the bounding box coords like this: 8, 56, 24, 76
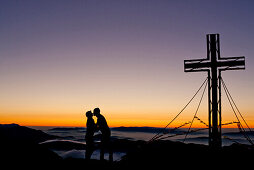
85, 111, 96, 160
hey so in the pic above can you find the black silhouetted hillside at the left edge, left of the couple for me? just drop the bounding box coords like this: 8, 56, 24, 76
0, 124, 61, 162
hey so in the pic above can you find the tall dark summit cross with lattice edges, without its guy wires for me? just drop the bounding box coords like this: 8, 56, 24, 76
184, 34, 245, 148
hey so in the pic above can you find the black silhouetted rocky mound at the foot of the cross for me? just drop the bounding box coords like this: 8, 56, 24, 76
119, 141, 254, 169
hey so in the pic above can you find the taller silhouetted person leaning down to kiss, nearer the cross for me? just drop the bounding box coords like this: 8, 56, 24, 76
93, 108, 113, 162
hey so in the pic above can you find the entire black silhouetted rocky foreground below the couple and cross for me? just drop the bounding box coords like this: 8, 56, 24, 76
0, 124, 254, 169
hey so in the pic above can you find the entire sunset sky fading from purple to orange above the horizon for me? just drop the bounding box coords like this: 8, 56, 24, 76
0, 0, 254, 127
